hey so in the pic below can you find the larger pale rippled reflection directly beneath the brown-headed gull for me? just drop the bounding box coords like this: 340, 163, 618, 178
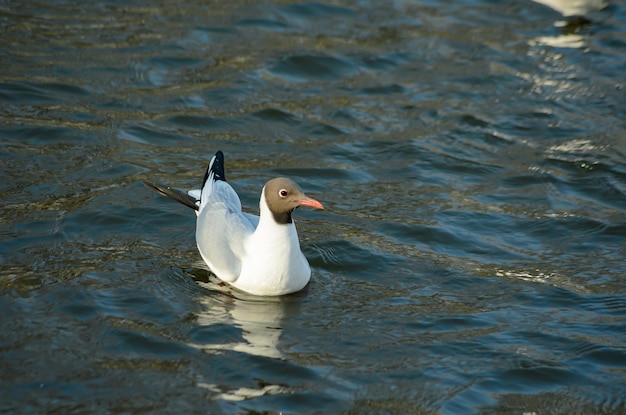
185, 269, 304, 359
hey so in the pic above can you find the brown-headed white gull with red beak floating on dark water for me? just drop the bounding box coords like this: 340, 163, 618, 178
144, 151, 324, 296
